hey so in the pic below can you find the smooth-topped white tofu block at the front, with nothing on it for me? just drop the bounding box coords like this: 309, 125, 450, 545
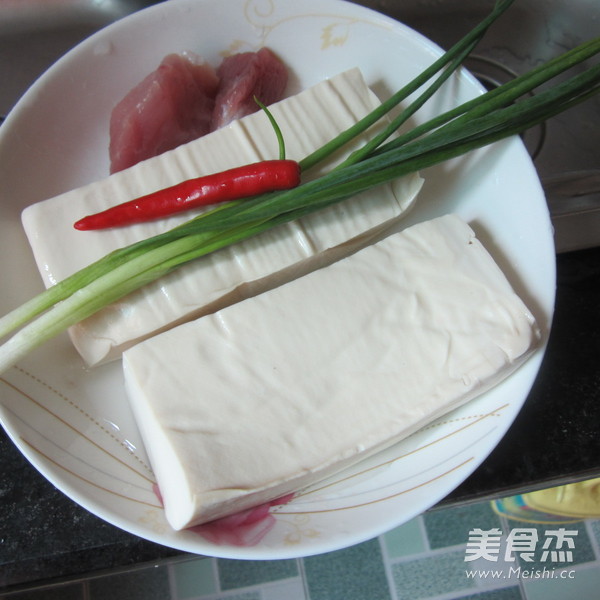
123, 215, 539, 529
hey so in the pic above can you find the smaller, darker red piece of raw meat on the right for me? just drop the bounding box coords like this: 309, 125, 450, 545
212, 48, 288, 131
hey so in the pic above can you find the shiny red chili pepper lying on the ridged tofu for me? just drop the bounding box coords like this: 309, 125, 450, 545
74, 160, 300, 231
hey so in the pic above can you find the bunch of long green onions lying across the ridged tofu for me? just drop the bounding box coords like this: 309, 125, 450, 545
0, 0, 600, 372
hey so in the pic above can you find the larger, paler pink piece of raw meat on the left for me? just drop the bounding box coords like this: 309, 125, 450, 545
109, 54, 219, 173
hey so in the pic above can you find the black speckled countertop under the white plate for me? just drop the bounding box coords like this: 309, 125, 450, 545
0, 248, 600, 591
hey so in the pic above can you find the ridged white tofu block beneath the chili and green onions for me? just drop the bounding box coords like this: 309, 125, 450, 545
22, 69, 422, 365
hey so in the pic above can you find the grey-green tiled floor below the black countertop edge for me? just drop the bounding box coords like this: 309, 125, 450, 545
4, 502, 600, 600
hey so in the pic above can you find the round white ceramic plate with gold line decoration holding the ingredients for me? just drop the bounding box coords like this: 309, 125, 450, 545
0, 0, 555, 559
